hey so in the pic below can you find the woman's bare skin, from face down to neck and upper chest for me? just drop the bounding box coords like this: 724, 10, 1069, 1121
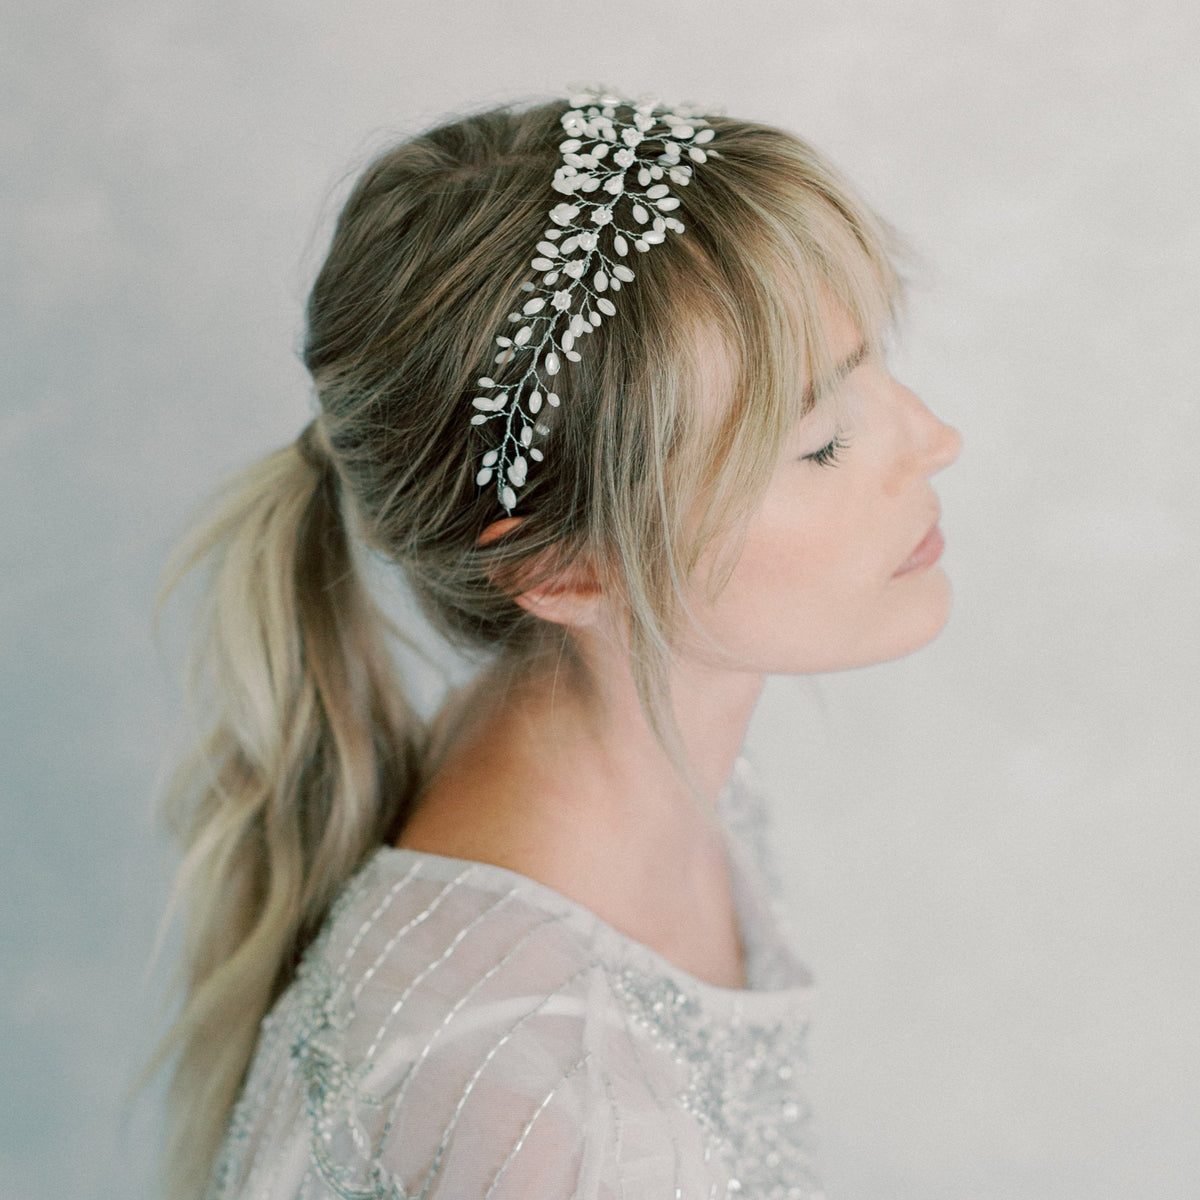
398, 297, 961, 988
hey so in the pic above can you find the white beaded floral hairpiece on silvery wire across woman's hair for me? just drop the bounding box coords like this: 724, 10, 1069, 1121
470, 91, 716, 512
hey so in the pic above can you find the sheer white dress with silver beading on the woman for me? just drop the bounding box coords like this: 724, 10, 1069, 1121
205, 758, 821, 1200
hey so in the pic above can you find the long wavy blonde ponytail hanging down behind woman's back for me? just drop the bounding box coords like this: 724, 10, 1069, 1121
151, 421, 425, 1200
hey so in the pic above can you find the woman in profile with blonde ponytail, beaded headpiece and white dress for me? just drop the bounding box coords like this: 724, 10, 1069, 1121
152, 92, 959, 1200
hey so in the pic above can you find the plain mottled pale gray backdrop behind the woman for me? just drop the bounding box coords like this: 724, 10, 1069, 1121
0, 0, 1200, 1200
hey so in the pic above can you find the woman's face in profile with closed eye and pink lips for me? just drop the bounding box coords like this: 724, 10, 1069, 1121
686, 300, 961, 674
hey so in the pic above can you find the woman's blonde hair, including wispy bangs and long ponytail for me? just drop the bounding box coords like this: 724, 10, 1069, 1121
147, 102, 898, 1198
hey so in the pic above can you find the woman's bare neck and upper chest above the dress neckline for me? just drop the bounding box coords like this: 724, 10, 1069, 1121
400, 638, 763, 986
